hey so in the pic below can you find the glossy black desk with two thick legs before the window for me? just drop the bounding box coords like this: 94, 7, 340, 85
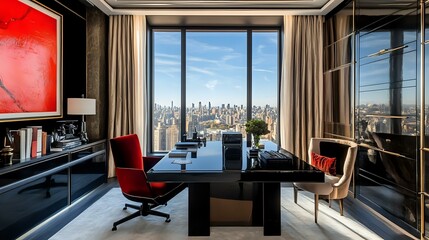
147, 142, 324, 236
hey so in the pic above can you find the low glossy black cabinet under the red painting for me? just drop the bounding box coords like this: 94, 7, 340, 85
0, 141, 107, 239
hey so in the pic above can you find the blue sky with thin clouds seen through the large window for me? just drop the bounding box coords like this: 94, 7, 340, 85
154, 31, 278, 106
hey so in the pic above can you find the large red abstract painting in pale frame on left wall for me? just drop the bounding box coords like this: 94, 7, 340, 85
0, 0, 63, 122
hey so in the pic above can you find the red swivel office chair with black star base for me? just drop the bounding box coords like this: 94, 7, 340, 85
110, 134, 186, 231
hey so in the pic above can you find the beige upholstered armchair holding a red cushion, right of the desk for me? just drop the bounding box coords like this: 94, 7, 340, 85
293, 138, 358, 223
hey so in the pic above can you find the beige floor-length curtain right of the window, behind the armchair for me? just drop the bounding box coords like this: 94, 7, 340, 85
280, 16, 323, 160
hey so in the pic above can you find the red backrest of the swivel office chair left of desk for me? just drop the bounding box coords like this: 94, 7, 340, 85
110, 134, 144, 169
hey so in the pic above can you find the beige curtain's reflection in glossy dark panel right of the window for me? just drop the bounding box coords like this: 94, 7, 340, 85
323, 2, 354, 138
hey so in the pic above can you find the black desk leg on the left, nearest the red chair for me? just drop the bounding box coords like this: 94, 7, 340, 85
188, 183, 210, 236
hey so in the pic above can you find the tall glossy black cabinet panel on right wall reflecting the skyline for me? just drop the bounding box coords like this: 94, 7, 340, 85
355, 0, 420, 231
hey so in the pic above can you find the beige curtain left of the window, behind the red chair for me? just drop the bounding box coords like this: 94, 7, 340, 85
108, 16, 147, 177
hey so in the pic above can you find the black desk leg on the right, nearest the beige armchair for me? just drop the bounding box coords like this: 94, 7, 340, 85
263, 183, 281, 236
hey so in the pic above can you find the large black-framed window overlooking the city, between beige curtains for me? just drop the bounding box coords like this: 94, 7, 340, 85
150, 28, 279, 152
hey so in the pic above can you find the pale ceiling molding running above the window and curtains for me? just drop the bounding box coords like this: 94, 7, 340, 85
86, 0, 343, 16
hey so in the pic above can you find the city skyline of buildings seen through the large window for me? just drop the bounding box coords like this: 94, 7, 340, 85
153, 102, 278, 151
